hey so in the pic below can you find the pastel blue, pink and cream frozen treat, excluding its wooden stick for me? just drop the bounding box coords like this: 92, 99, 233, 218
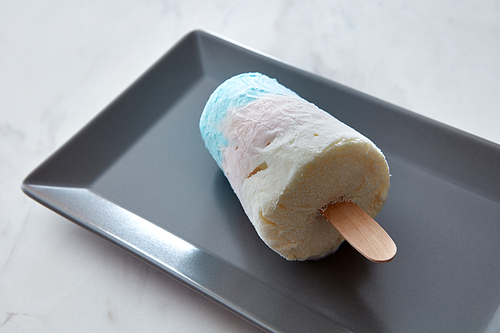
200, 73, 389, 260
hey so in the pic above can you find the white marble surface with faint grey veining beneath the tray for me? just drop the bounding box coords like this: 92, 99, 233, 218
0, 0, 500, 332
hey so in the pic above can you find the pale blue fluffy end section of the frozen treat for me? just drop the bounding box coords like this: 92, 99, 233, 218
200, 73, 298, 170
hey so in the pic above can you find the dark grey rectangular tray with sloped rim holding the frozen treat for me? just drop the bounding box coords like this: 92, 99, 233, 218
22, 31, 500, 332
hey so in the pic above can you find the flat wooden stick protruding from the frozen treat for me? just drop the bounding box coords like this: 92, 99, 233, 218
323, 202, 397, 262
